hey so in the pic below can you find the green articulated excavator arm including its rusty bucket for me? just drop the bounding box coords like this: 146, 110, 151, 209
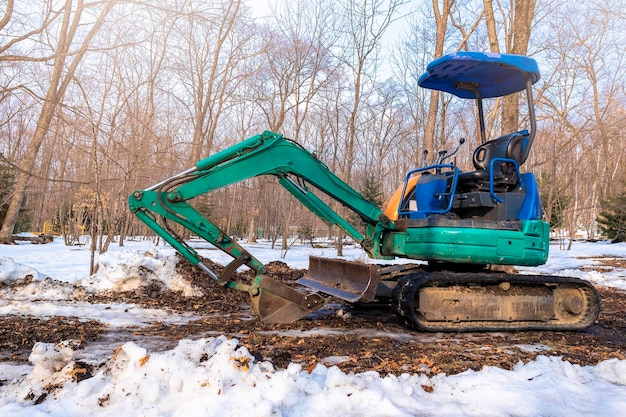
129, 132, 395, 322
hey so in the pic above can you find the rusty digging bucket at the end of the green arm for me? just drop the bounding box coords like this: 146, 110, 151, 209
252, 276, 325, 324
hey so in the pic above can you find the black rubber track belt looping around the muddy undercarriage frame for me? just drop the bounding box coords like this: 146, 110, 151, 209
392, 271, 600, 332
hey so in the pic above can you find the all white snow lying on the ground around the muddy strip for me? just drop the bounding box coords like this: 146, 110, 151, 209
0, 236, 626, 417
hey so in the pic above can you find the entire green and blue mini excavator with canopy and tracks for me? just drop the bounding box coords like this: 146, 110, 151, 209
128, 52, 600, 331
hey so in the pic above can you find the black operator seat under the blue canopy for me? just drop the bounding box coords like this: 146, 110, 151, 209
457, 131, 528, 192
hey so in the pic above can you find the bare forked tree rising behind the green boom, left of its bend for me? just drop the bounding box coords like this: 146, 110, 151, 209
170, 0, 255, 160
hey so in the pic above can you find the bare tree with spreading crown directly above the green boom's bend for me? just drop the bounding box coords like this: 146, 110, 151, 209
255, 0, 339, 141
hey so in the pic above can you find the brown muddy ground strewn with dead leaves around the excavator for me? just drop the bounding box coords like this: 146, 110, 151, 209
0, 260, 626, 375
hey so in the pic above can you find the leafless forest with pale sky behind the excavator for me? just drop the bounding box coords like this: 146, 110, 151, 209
0, 0, 626, 252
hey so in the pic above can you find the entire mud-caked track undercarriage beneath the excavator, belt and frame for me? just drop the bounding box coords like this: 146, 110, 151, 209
393, 266, 599, 331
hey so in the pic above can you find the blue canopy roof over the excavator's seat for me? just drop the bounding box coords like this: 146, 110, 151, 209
418, 52, 541, 98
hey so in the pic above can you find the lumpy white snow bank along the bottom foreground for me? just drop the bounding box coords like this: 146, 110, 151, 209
0, 336, 626, 417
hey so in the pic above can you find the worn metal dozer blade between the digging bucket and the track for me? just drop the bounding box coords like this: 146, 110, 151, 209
297, 256, 380, 303
